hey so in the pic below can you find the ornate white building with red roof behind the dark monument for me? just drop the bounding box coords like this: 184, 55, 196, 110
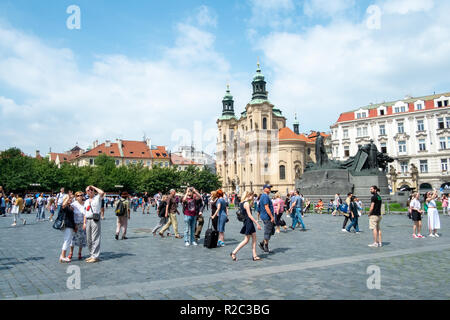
331, 93, 450, 193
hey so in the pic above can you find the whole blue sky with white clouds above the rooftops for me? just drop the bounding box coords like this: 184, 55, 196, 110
0, 0, 450, 155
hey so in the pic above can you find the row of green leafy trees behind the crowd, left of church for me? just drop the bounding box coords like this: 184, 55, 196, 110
0, 148, 221, 194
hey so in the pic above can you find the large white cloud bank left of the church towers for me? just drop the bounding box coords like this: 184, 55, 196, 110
0, 23, 234, 153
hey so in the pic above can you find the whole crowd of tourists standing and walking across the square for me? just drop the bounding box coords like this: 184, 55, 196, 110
0, 184, 449, 263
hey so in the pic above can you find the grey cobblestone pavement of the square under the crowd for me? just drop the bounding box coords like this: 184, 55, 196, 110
0, 209, 450, 300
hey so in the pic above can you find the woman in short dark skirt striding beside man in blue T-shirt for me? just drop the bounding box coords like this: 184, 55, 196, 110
230, 191, 261, 261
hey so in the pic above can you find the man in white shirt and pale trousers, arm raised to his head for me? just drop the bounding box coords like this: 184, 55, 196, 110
83, 186, 105, 263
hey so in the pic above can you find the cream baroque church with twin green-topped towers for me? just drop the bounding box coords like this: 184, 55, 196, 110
216, 63, 327, 195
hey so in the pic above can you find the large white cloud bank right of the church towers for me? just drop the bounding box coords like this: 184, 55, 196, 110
257, 2, 450, 131
